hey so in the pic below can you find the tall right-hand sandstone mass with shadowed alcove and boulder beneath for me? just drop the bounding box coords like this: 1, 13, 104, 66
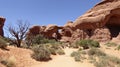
71, 0, 120, 42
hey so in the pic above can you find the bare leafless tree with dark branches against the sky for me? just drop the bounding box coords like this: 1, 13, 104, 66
8, 20, 30, 47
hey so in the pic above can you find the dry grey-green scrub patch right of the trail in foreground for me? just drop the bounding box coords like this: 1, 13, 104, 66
71, 48, 120, 67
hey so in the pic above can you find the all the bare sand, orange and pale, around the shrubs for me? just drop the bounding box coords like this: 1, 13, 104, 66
0, 40, 120, 67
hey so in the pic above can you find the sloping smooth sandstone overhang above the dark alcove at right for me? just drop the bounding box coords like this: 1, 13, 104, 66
73, 0, 120, 29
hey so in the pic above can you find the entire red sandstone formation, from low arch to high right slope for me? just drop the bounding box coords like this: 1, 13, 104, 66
27, 0, 120, 42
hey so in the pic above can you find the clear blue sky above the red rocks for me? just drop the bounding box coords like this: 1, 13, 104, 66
0, 0, 100, 36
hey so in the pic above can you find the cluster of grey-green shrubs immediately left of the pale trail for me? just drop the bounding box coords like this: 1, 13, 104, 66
32, 42, 65, 61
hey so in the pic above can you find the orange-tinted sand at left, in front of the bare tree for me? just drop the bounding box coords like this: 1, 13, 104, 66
0, 46, 40, 67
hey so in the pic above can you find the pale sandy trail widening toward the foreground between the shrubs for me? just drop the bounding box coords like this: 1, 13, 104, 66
31, 48, 94, 67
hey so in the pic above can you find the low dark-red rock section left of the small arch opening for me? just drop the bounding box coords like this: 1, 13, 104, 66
27, 25, 58, 38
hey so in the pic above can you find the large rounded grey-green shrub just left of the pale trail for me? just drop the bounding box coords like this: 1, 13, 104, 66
32, 46, 51, 61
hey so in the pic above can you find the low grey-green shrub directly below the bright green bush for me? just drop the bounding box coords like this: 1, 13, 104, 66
88, 48, 106, 56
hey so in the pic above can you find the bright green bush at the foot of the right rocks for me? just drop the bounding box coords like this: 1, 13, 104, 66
76, 39, 100, 49
